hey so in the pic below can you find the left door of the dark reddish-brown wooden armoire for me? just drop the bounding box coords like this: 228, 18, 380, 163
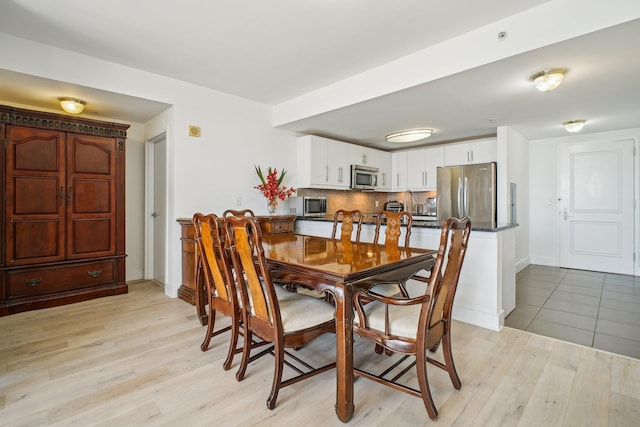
5, 125, 66, 267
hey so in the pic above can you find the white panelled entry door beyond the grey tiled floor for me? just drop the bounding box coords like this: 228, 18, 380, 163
558, 140, 635, 274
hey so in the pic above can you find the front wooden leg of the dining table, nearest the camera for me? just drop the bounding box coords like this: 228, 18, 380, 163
334, 284, 354, 422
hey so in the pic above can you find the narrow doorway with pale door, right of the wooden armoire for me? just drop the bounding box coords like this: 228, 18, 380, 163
145, 134, 167, 286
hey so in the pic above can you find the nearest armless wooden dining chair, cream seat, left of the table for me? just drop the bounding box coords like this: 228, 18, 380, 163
225, 216, 336, 409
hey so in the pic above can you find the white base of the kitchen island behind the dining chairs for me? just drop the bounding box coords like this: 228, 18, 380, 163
295, 215, 517, 331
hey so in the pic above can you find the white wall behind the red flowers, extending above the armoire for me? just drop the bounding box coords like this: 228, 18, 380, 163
0, 34, 296, 296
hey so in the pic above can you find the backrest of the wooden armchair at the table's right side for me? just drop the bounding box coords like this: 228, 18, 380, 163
420, 217, 471, 348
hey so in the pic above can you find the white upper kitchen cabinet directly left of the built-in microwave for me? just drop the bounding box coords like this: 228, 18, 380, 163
297, 135, 353, 189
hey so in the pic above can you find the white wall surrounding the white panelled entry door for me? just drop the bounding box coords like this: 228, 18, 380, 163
529, 128, 640, 274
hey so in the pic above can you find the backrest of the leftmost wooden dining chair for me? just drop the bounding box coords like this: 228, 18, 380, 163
193, 213, 237, 308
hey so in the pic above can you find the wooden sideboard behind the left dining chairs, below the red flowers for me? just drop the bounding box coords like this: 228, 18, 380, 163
177, 215, 296, 325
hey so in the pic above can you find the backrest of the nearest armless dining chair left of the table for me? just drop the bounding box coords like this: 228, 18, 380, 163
224, 216, 282, 338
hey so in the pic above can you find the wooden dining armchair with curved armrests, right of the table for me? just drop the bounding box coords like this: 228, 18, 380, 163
354, 217, 471, 420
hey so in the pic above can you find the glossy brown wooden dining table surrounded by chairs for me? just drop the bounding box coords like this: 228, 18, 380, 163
263, 233, 436, 422
